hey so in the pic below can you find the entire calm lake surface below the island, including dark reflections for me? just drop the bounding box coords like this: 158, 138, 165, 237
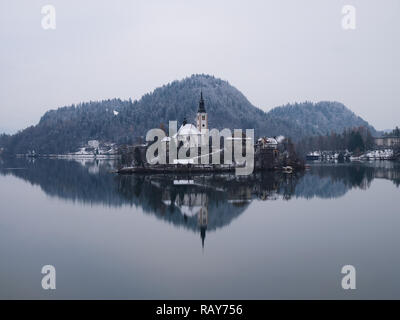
0, 159, 400, 299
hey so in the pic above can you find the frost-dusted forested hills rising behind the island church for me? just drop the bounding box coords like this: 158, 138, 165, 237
0, 75, 375, 154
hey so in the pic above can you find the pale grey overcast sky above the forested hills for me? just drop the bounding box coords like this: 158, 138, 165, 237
0, 0, 400, 131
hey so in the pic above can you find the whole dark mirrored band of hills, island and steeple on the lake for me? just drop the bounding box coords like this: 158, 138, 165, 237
0, 159, 400, 245
